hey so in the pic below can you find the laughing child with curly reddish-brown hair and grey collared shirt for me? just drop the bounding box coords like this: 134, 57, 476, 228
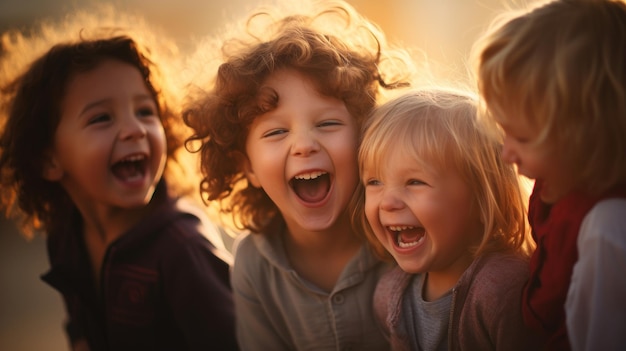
184, 2, 412, 350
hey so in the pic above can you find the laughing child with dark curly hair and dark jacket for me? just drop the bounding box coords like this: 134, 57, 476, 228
0, 7, 237, 351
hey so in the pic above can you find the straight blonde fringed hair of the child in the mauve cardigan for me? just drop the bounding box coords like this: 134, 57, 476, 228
353, 89, 532, 258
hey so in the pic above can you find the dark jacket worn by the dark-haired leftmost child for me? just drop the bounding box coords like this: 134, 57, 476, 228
42, 182, 237, 351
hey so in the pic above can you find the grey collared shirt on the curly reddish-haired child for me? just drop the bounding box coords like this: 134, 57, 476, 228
231, 234, 389, 351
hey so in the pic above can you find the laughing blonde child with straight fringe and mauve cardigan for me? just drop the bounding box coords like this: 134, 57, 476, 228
357, 89, 532, 350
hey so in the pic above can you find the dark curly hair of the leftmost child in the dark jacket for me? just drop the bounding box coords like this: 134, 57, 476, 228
0, 9, 193, 237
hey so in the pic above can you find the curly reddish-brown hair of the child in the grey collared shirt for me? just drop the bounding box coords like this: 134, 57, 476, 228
183, 2, 413, 233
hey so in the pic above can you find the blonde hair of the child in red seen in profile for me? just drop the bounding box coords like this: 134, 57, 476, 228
474, 0, 626, 193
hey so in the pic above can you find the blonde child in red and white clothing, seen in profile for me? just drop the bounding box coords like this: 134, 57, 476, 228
476, 0, 626, 350
